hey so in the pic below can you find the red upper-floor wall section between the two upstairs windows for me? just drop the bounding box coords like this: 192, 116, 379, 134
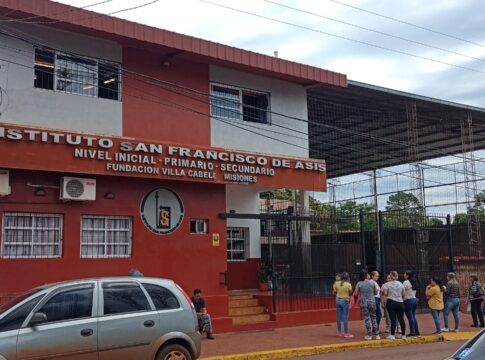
122, 47, 210, 146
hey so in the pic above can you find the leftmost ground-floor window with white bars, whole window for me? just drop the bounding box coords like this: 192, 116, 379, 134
2, 213, 62, 258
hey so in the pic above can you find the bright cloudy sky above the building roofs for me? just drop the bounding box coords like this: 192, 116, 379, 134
60, 0, 485, 107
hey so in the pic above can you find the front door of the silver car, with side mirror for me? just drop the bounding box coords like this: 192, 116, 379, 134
17, 282, 98, 360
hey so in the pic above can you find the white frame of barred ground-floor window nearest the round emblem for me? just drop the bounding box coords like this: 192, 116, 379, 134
79, 215, 133, 259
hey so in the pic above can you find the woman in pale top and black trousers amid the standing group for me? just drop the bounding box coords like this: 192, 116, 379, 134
382, 271, 406, 340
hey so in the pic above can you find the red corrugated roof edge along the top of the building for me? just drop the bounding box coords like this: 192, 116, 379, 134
0, 0, 347, 87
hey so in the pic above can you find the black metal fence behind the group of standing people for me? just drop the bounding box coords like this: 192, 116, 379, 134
261, 212, 485, 312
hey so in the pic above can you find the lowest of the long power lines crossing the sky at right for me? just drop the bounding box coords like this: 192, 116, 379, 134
198, 0, 485, 74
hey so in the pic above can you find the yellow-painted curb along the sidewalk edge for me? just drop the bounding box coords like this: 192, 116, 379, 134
200, 332, 475, 360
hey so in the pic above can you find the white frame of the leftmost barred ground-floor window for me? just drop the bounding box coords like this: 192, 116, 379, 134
0, 211, 64, 259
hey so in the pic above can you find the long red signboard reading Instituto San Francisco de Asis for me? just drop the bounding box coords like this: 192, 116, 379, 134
0, 125, 326, 191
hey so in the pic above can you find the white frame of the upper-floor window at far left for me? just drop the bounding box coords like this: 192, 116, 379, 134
33, 47, 121, 101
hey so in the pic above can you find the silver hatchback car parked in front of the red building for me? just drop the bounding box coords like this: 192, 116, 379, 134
0, 277, 201, 360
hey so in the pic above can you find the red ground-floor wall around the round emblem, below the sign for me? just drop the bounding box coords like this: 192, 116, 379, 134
0, 171, 227, 308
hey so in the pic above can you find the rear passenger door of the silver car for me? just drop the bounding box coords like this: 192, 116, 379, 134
98, 281, 159, 360
